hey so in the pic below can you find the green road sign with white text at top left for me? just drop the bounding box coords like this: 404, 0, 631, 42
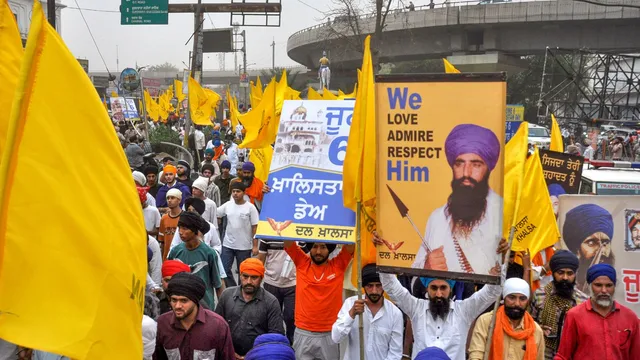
120, 0, 169, 25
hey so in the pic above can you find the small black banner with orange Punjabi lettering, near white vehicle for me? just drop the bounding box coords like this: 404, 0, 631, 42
539, 150, 584, 194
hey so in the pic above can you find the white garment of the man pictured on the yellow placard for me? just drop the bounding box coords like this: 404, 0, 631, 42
412, 189, 502, 274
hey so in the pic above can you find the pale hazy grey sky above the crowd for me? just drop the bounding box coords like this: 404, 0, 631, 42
58, 0, 442, 72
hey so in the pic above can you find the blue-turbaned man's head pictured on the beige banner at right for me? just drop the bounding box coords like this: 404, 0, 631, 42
562, 204, 615, 291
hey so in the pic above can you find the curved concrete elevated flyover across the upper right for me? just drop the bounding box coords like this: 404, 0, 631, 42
287, 0, 640, 72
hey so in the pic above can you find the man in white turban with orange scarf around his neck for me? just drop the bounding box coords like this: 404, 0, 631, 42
469, 278, 544, 360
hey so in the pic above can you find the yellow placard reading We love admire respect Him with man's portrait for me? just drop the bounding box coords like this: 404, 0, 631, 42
376, 73, 506, 283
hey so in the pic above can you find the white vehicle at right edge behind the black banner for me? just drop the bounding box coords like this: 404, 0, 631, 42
580, 160, 640, 195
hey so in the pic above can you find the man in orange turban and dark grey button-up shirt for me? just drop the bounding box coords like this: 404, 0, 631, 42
216, 258, 284, 358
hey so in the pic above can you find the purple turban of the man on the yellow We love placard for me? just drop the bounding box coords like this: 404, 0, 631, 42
444, 124, 500, 170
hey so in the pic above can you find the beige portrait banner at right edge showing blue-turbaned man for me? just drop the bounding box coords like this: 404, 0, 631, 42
558, 195, 640, 315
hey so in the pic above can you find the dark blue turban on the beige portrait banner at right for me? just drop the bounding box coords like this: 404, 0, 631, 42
562, 204, 613, 254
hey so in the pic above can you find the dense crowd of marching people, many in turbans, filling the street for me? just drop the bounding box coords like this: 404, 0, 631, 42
0, 117, 640, 360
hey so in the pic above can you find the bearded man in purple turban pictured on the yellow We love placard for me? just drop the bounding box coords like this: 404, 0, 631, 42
413, 124, 502, 274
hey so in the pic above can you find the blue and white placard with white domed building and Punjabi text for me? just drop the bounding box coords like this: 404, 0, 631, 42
256, 100, 356, 244
